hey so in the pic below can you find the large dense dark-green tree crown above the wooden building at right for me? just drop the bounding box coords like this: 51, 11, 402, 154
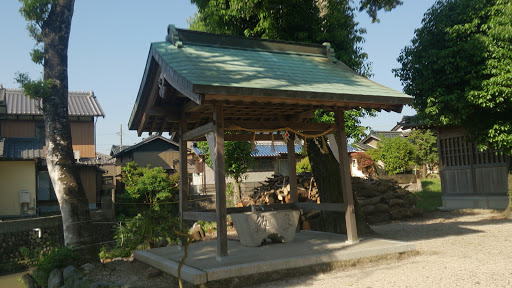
394, 0, 512, 152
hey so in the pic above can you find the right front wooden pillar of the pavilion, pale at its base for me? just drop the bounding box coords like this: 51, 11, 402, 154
336, 108, 359, 243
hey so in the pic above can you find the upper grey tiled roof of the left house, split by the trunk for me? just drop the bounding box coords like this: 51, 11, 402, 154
0, 88, 105, 117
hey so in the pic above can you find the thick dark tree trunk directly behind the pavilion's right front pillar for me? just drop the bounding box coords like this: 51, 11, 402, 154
307, 140, 372, 235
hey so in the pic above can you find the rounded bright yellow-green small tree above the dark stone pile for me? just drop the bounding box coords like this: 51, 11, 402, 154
372, 137, 414, 175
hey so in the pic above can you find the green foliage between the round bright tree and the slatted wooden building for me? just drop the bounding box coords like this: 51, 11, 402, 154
407, 129, 439, 170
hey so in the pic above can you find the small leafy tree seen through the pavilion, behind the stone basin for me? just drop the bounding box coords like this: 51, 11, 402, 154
197, 141, 254, 203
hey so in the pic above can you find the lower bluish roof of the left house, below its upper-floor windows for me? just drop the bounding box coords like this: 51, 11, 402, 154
0, 138, 45, 159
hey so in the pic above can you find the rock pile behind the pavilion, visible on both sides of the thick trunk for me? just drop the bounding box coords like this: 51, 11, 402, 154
247, 173, 422, 224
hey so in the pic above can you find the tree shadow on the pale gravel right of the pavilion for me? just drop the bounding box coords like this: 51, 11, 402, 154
372, 211, 512, 241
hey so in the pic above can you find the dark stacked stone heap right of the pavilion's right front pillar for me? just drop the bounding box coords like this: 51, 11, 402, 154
352, 177, 423, 224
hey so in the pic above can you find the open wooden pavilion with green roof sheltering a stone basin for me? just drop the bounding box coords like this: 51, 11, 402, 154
129, 25, 412, 259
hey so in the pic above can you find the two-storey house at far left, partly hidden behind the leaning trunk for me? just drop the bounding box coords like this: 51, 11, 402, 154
0, 85, 105, 217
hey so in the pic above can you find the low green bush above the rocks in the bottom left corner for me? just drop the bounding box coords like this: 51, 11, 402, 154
32, 247, 79, 287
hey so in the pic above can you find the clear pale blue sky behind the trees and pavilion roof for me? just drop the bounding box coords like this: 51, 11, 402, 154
0, 0, 435, 154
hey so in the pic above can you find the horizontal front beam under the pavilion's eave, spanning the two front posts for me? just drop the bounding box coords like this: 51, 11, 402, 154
225, 121, 337, 132
